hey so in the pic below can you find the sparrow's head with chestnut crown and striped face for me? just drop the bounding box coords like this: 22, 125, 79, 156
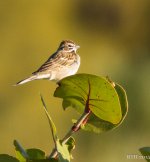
58, 40, 80, 52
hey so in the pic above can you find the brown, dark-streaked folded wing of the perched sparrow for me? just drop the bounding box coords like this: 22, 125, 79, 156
33, 52, 76, 74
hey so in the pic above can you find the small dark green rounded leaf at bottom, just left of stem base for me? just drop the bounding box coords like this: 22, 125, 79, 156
26, 148, 46, 160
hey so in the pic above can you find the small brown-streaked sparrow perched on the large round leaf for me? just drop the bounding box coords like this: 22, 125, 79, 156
15, 40, 80, 86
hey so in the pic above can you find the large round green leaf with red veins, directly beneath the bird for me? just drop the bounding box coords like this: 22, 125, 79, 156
54, 74, 122, 124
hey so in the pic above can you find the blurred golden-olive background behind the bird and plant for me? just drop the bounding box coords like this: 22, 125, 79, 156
0, 0, 150, 162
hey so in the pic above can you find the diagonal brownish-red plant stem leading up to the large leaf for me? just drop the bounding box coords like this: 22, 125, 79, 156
49, 110, 91, 158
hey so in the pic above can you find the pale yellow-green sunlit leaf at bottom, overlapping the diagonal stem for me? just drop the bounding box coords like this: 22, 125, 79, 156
56, 140, 71, 162
